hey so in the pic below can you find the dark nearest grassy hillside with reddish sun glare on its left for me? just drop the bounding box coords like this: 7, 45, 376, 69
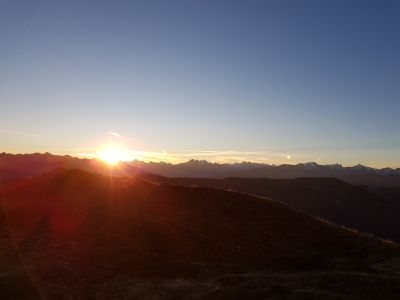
0, 169, 400, 299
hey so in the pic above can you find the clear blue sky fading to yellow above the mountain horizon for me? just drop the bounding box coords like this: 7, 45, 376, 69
0, 0, 400, 167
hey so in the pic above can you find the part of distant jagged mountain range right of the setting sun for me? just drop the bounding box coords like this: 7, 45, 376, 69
129, 160, 400, 187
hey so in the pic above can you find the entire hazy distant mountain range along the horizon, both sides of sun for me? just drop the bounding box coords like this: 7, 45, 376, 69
0, 153, 400, 187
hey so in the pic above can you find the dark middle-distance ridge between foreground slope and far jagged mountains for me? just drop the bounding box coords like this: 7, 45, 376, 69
142, 175, 400, 242
